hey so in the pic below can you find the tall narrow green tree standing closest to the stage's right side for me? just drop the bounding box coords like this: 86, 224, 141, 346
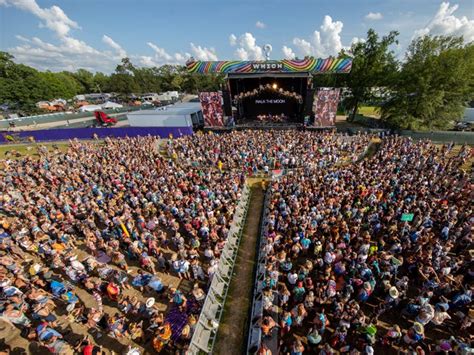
342, 29, 398, 121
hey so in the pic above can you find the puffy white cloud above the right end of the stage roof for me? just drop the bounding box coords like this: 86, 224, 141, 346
293, 15, 352, 57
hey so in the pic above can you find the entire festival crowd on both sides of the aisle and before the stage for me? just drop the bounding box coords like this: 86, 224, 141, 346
0, 130, 474, 355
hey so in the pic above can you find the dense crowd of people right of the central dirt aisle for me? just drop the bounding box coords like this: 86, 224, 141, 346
259, 136, 474, 354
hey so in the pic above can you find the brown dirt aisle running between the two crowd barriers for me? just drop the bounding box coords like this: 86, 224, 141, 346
214, 179, 264, 355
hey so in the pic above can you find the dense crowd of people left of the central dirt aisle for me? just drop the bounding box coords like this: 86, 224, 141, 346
0, 137, 244, 354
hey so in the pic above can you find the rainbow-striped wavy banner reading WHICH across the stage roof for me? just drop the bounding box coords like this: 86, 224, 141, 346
186, 57, 352, 74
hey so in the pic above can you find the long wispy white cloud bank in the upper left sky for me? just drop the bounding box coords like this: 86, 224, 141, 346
0, 0, 217, 73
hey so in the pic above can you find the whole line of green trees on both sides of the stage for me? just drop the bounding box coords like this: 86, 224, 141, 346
0, 29, 474, 129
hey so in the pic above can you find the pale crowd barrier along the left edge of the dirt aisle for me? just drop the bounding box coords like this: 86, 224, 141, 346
188, 185, 250, 355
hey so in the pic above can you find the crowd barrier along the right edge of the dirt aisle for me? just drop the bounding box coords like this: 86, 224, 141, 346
247, 189, 270, 354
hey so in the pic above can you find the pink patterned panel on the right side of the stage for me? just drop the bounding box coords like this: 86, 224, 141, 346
313, 88, 340, 127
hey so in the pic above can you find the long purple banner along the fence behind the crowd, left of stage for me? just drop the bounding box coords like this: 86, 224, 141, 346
0, 127, 193, 143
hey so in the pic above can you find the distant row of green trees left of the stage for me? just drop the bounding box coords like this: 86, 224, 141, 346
0, 52, 224, 113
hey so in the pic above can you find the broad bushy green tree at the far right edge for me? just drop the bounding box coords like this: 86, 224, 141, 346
381, 36, 474, 129
